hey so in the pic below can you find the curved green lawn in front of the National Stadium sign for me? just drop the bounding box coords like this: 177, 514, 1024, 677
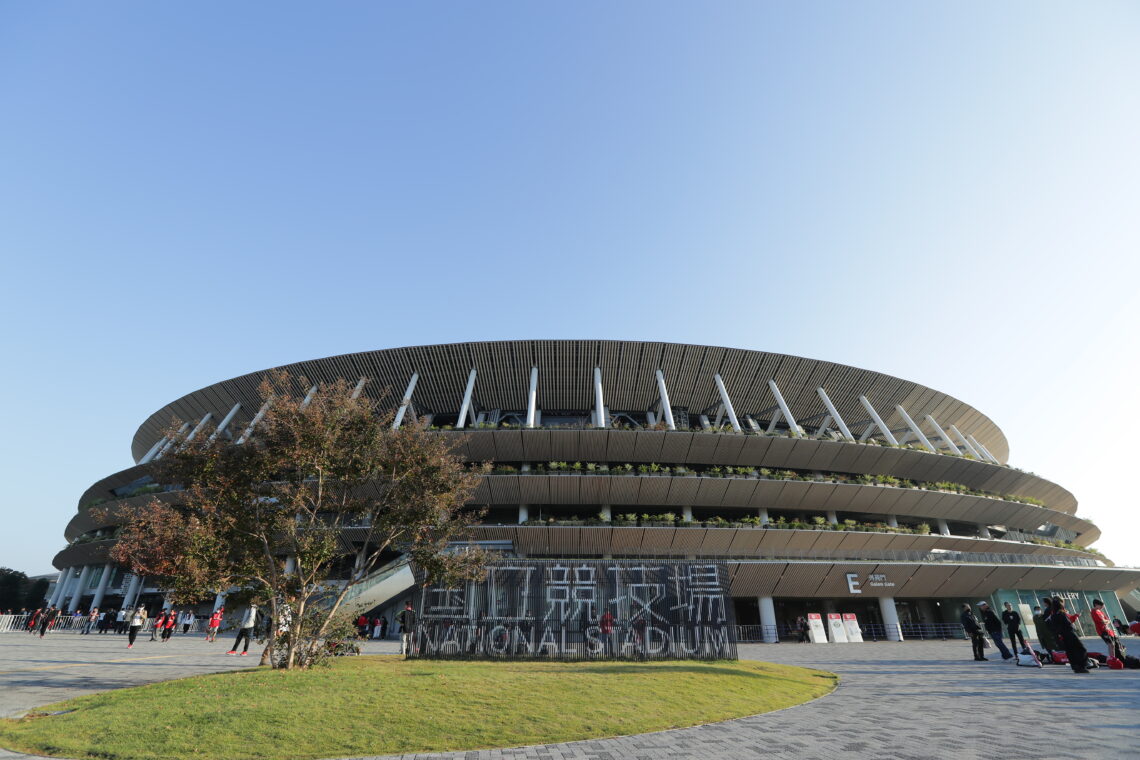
0, 656, 838, 760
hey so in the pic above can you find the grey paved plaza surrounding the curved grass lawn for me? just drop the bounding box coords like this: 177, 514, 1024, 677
0, 634, 1140, 760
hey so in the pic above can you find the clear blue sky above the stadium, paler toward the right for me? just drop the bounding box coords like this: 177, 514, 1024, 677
0, 1, 1140, 573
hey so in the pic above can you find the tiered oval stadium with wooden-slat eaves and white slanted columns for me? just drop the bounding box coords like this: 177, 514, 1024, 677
51, 341, 1140, 640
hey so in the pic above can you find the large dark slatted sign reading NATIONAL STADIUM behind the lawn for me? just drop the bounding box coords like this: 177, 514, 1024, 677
412, 559, 736, 660
